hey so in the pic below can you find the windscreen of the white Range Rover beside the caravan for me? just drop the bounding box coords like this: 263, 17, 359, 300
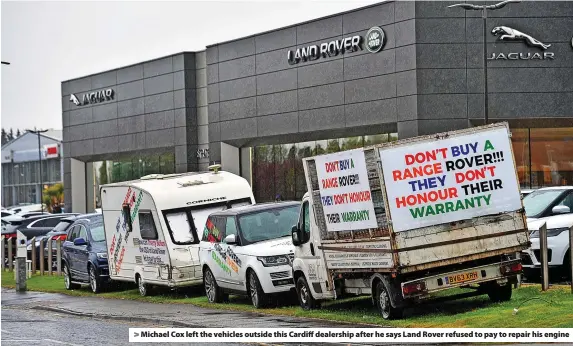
239, 205, 300, 245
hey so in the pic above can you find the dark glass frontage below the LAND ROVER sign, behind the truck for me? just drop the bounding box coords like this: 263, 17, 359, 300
251, 133, 398, 202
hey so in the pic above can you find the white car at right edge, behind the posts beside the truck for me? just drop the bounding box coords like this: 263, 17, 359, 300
522, 186, 573, 276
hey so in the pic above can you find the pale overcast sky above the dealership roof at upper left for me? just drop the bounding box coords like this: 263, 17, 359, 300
1, 0, 380, 130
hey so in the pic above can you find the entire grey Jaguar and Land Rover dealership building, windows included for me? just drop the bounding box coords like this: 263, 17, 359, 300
62, 1, 573, 212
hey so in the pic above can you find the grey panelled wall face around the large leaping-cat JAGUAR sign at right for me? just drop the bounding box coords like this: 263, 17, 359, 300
409, 1, 573, 135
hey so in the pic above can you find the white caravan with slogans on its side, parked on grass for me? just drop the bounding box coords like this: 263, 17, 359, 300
100, 165, 255, 296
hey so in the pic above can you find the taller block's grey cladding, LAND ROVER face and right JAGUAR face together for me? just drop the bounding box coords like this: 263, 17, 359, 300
207, 1, 573, 165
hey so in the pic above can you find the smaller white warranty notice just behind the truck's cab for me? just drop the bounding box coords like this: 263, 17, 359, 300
315, 149, 378, 232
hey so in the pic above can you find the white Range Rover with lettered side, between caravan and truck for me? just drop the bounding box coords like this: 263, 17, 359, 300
199, 202, 300, 308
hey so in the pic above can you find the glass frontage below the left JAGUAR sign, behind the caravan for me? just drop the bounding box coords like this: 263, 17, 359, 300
92, 153, 175, 209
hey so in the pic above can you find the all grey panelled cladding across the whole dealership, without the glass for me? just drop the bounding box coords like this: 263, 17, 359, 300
62, 1, 573, 211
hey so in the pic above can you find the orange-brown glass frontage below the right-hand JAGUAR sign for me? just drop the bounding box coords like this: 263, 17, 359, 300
511, 127, 573, 189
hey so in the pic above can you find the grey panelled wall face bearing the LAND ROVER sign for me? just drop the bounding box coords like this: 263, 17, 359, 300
207, 2, 406, 164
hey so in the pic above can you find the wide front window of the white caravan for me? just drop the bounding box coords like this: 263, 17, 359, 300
163, 198, 252, 245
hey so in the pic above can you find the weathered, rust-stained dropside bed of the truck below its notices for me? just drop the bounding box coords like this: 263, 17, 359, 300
304, 125, 529, 273
